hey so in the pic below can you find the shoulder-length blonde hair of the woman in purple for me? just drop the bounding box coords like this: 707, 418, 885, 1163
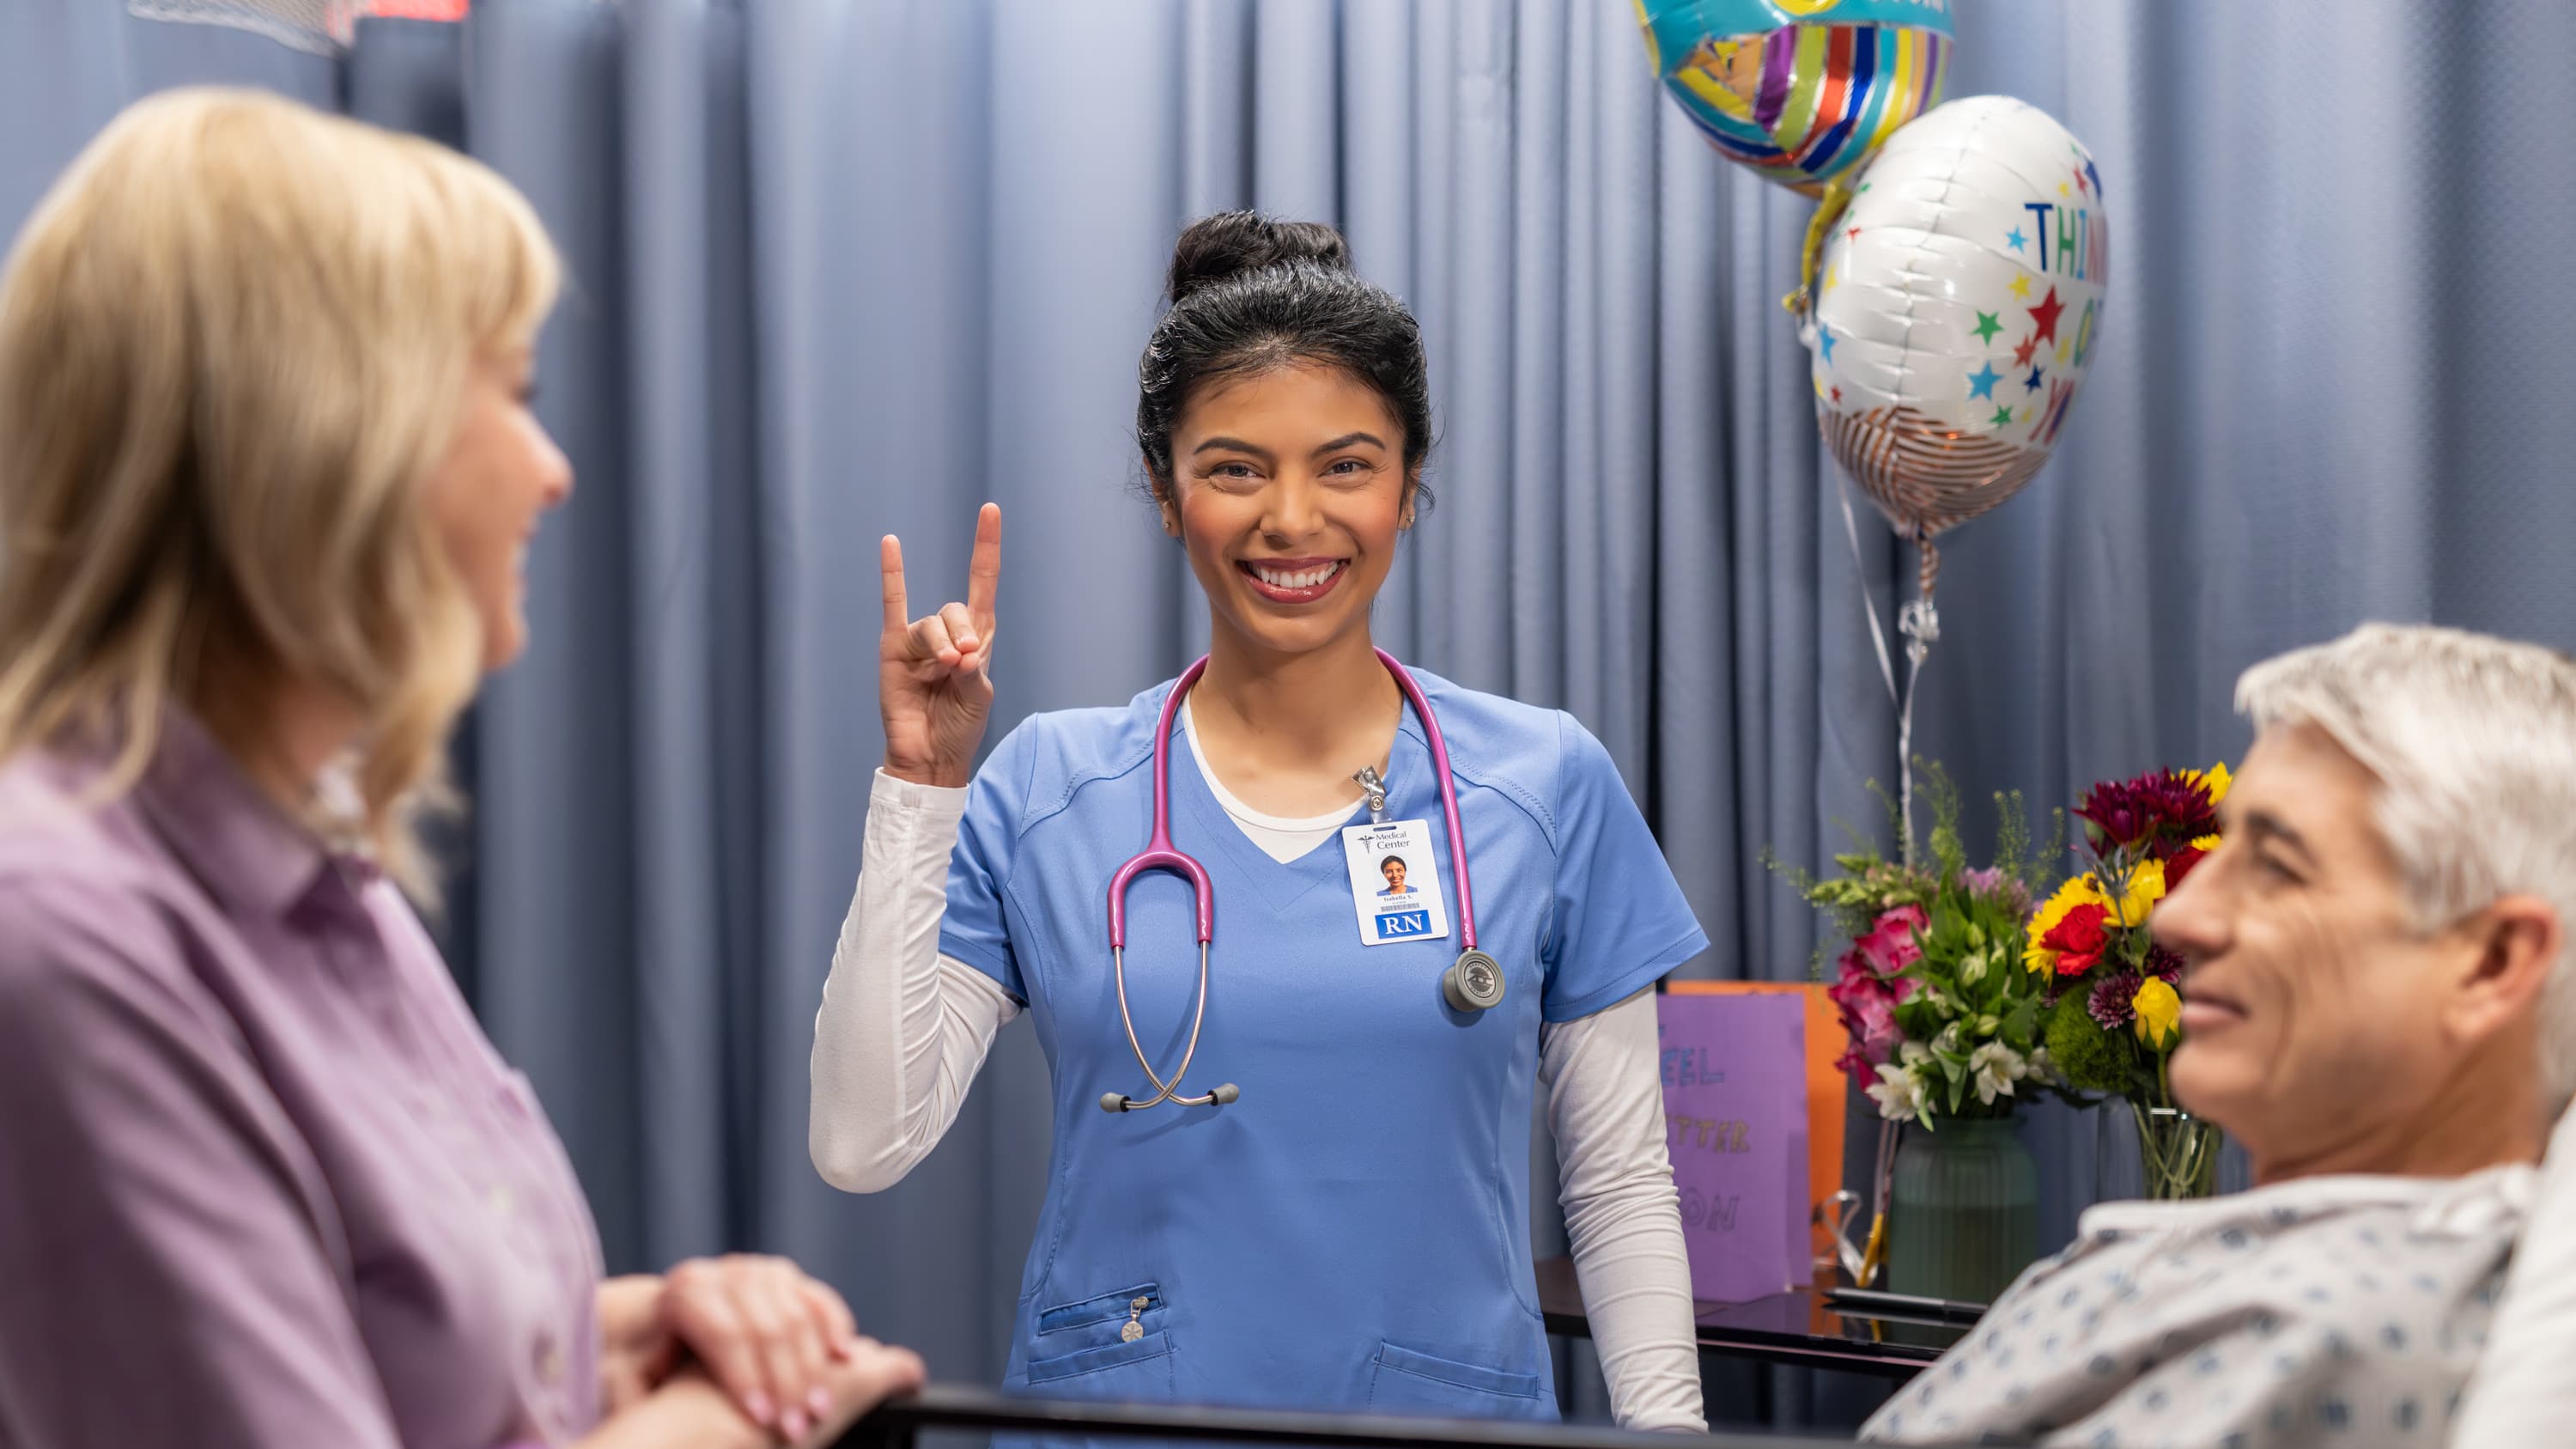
0, 90, 559, 895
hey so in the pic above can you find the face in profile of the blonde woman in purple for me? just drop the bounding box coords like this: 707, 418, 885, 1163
425, 348, 572, 670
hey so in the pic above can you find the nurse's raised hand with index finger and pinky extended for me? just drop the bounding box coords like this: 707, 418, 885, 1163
876, 502, 1002, 787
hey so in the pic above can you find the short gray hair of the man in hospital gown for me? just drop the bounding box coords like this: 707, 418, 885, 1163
2236, 624, 2576, 1114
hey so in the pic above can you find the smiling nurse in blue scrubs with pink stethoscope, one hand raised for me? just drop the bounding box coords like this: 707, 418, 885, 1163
811, 214, 1708, 1431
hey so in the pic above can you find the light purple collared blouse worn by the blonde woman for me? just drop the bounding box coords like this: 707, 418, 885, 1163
0, 714, 600, 1449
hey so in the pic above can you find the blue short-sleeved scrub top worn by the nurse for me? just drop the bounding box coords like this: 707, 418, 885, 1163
940, 673, 1708, 1418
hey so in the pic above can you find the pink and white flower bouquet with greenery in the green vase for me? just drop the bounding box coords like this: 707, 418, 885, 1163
1790, 766, 2053, 1129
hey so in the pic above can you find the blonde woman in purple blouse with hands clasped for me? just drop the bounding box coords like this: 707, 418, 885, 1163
0, 90, 922, 1449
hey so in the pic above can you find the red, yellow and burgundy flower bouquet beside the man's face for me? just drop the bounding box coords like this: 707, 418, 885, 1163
2022, 766, 2228, 1199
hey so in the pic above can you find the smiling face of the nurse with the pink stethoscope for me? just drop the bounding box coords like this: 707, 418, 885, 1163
1157, 363, 1414, 654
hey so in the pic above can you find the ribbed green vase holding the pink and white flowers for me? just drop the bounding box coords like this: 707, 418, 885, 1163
1888, 1117, 2040, 1302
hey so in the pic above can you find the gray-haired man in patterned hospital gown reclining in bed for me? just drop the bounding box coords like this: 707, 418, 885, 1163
1862, 626, 2576, 1446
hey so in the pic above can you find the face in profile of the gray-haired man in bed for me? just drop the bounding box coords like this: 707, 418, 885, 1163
2154, 725, 2483, 1163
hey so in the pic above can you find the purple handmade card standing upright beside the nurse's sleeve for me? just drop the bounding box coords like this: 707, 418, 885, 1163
1656, 993, 1811, 1302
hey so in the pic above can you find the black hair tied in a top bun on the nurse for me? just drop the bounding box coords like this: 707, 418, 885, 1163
1136, 211, 1432, 508
